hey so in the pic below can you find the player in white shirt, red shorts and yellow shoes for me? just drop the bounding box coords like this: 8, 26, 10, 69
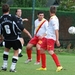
37, 6, 63, 72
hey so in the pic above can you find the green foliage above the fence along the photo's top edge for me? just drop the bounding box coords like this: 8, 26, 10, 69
0, 0, 75, 11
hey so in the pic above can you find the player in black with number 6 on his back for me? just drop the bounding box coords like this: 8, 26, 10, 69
0, 4, 32, 72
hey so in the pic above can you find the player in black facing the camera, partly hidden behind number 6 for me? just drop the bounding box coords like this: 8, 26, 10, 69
16, 9, 28, 57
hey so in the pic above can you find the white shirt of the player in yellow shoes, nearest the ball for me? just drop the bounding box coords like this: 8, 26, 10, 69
45, 15, 59, 40
